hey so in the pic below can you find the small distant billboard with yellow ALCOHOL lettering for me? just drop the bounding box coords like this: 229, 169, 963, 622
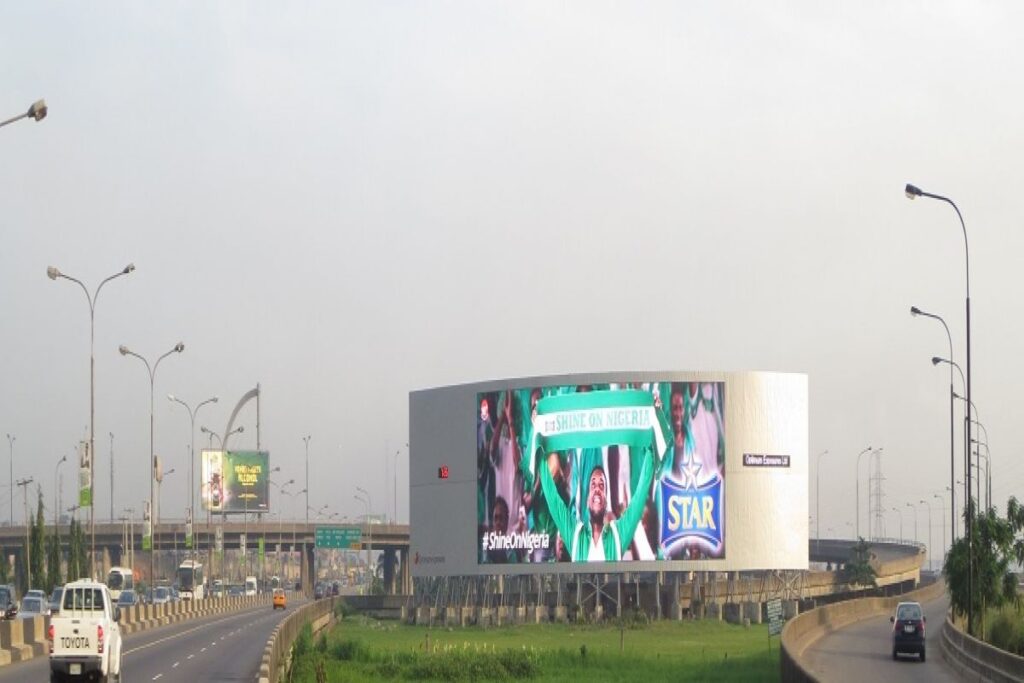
202, 451, 270, 512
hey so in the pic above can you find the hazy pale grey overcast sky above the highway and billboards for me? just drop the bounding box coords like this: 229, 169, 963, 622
0, 1, 1024, 557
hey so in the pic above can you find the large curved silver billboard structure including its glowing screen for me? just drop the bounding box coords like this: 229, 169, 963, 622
410, 372, 808, 577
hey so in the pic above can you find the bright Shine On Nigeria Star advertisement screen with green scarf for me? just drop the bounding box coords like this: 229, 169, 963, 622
476, 381, 726, 564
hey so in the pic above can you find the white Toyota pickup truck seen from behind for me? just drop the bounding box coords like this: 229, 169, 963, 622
46, 579, 121, 683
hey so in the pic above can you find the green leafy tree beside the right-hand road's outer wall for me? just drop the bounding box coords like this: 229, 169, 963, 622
942, 498, 1024, 637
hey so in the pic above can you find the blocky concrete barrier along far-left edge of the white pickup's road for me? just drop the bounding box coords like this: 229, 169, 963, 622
0, 595, 270, 666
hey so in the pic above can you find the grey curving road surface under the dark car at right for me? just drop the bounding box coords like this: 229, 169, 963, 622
804, 595, 959, 683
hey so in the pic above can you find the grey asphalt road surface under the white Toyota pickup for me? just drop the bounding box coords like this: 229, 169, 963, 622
0, 595, 302, 683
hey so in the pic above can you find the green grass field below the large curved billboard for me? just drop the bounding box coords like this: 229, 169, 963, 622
284, 616, 780, 683
